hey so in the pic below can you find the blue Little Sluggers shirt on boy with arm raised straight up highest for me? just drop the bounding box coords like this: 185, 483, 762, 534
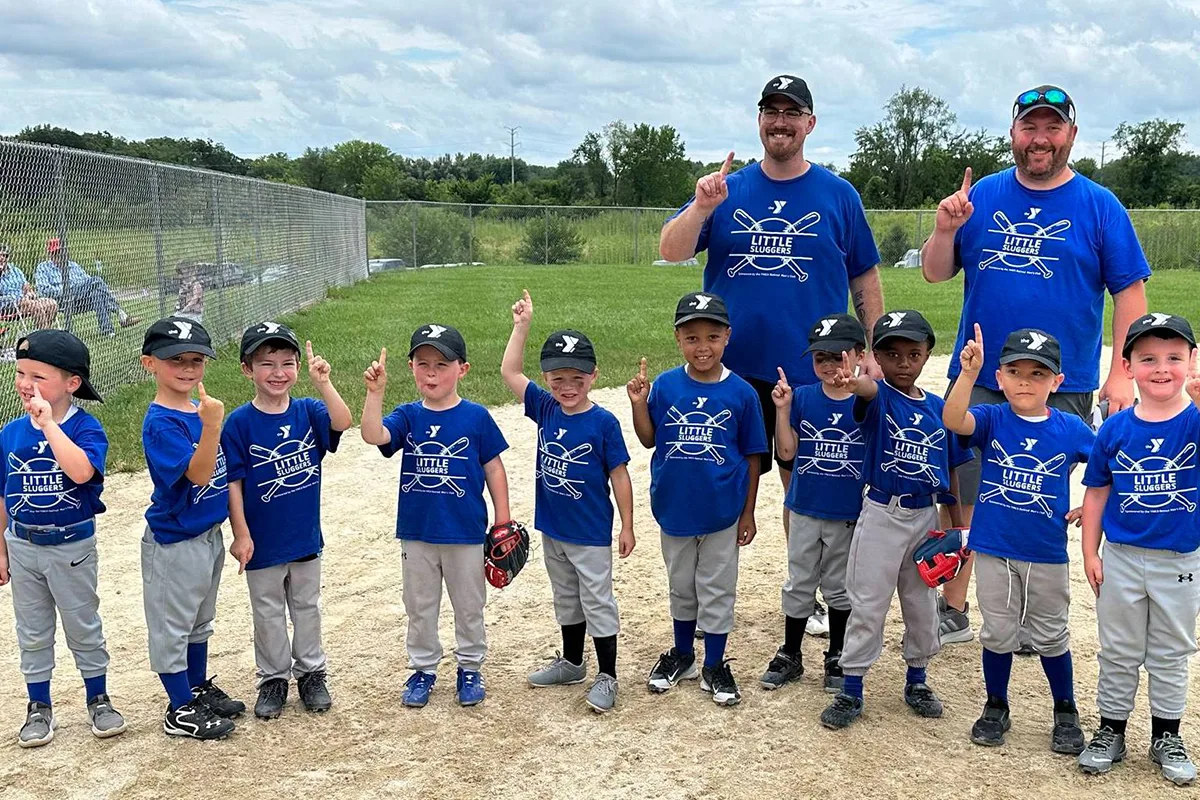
526, 380, 629, 547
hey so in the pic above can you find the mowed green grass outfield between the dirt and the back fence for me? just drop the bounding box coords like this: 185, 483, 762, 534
97, 265, 1200, 471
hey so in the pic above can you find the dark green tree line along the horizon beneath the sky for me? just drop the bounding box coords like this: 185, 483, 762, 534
10, 86, 1200, 209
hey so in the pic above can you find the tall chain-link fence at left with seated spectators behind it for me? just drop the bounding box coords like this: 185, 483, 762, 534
0, 140, 367, 420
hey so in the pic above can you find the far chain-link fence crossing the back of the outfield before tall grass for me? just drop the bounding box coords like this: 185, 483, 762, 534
366, 200, 1200, 270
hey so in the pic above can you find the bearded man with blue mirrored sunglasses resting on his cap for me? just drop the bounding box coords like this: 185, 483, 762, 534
922, 86, 1150, 644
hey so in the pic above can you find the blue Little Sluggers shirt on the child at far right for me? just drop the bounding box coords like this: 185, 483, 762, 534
1084, 403, 1200, 553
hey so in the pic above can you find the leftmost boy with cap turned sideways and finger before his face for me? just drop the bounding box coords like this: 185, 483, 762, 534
0, 330, 125, 747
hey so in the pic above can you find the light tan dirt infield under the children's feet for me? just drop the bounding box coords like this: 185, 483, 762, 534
0, 354, 1200, 800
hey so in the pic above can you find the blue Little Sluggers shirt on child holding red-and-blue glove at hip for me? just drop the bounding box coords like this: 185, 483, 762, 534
854, 380, 974, 495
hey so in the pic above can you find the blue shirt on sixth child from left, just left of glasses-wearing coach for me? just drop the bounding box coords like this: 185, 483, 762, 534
647, 367, 767, 536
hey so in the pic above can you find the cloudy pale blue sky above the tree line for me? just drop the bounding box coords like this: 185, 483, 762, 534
0, 0, 1200, 166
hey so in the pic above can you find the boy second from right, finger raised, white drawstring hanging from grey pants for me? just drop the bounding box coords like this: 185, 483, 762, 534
942, 325, 1096, 756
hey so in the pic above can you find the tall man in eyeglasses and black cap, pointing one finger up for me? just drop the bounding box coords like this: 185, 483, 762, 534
659, 76, 883, 563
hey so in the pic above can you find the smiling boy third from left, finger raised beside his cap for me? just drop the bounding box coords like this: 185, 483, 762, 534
221, 323, 352, 720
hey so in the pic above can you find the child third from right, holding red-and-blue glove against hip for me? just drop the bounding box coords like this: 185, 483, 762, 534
821, 311, 971, 729
